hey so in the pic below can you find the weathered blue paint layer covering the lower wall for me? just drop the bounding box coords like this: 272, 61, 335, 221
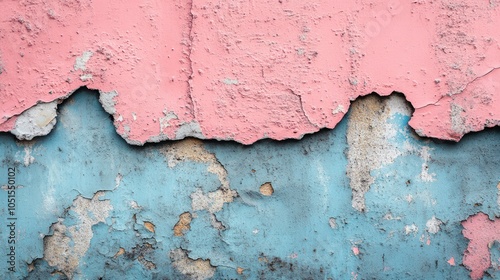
0, 90, 500, 279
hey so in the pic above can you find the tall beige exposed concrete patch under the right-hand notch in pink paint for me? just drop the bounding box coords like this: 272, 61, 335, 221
347, 95, 411, 212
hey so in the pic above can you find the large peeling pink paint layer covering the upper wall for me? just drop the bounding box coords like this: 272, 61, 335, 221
0, 0, 500, 144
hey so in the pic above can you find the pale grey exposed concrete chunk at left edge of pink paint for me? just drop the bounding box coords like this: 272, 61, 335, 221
10, 101, 57, 140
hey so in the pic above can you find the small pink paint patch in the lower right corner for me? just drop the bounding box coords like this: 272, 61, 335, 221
462, 213, 500, 279
